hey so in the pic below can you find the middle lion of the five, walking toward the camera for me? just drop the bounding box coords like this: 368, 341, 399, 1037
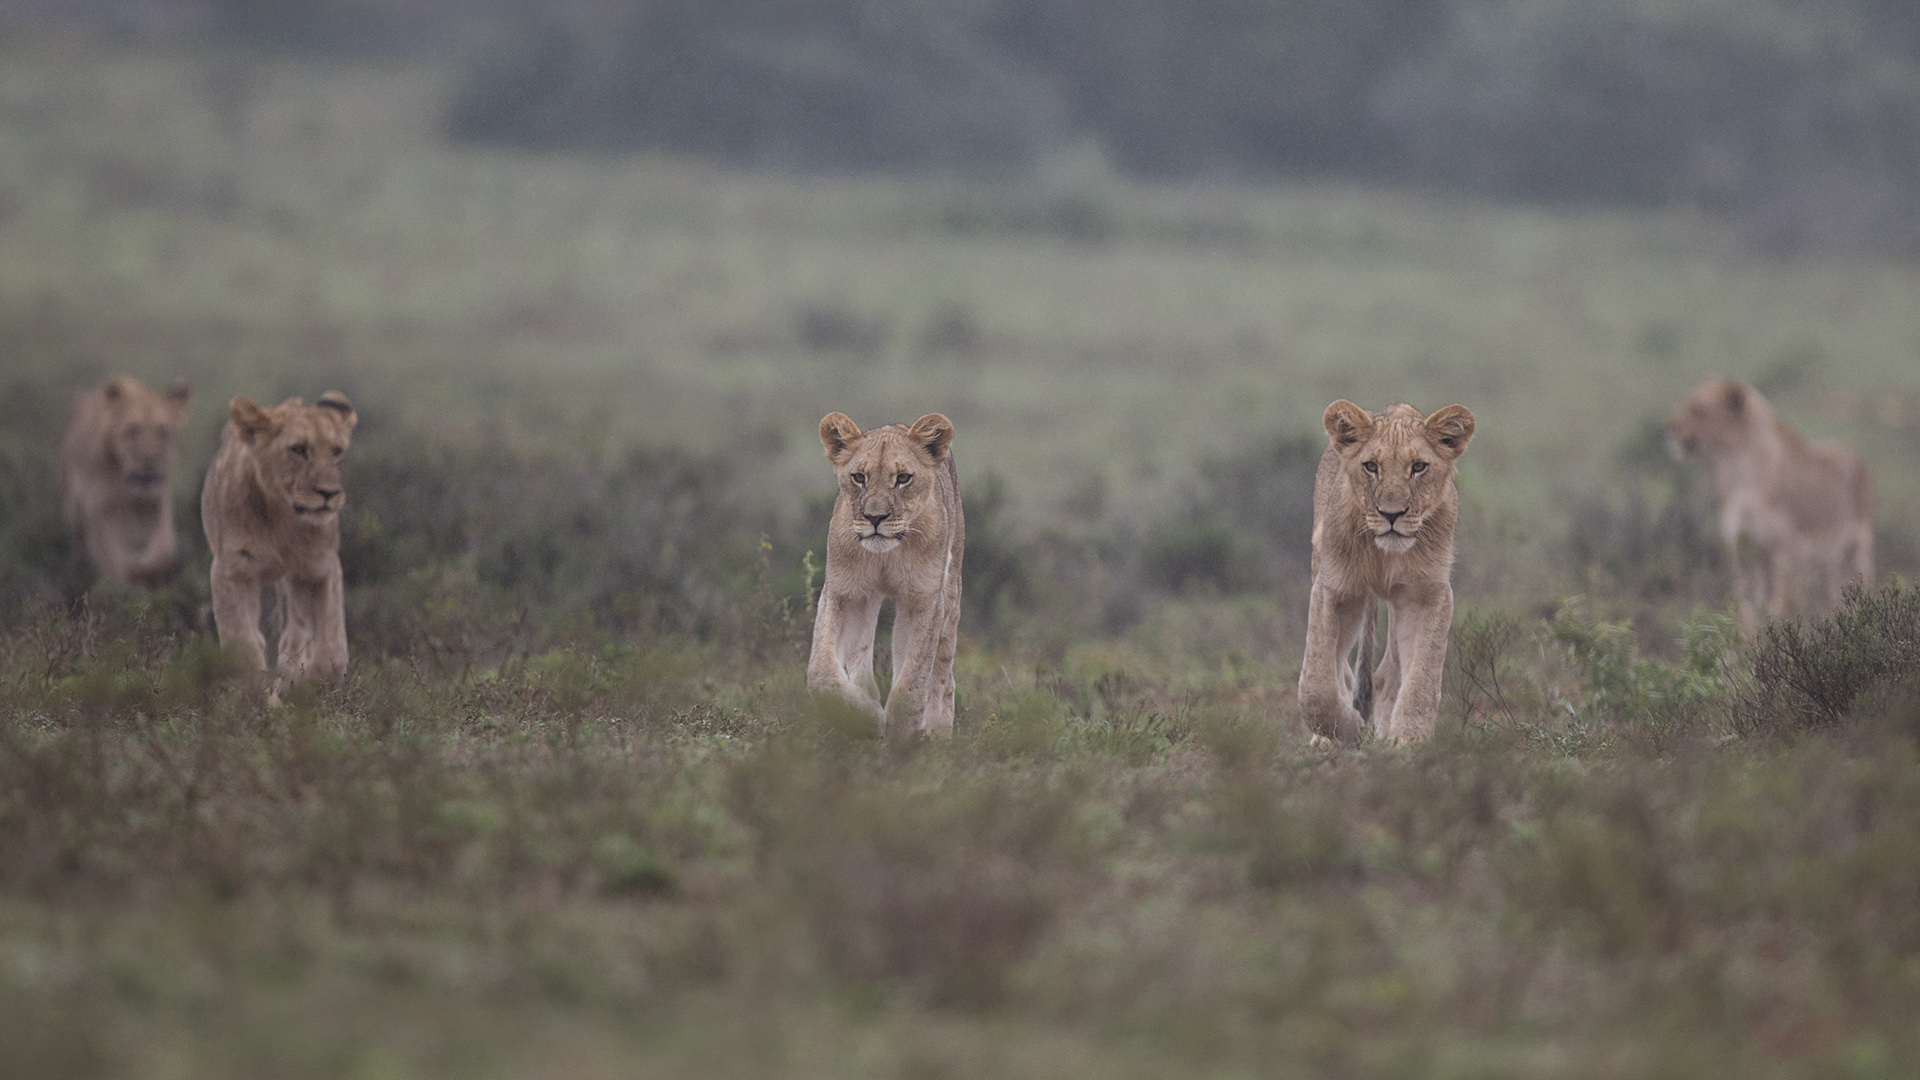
806, 413, 966, 738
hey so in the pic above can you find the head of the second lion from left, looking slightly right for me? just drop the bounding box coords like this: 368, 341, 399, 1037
228, 390, 359, 525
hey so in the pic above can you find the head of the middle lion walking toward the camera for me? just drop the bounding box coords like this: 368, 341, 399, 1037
820, 413, 954, 553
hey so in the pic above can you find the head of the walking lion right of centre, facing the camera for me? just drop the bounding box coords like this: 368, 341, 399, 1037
1323, 400, 1473, 553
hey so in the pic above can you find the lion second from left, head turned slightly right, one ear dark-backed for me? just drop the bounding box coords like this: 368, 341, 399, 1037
200, 390, 359, 701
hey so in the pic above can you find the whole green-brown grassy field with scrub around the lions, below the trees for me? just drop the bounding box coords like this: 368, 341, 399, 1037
11, 27, 1920, 1078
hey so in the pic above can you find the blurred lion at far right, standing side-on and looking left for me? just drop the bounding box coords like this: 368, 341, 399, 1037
1667, 377, 1874, 634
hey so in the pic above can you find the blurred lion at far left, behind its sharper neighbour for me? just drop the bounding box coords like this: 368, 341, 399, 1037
60, 375, 194, 586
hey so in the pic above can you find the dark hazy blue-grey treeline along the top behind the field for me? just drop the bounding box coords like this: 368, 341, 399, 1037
33, 0, 1920, 254
